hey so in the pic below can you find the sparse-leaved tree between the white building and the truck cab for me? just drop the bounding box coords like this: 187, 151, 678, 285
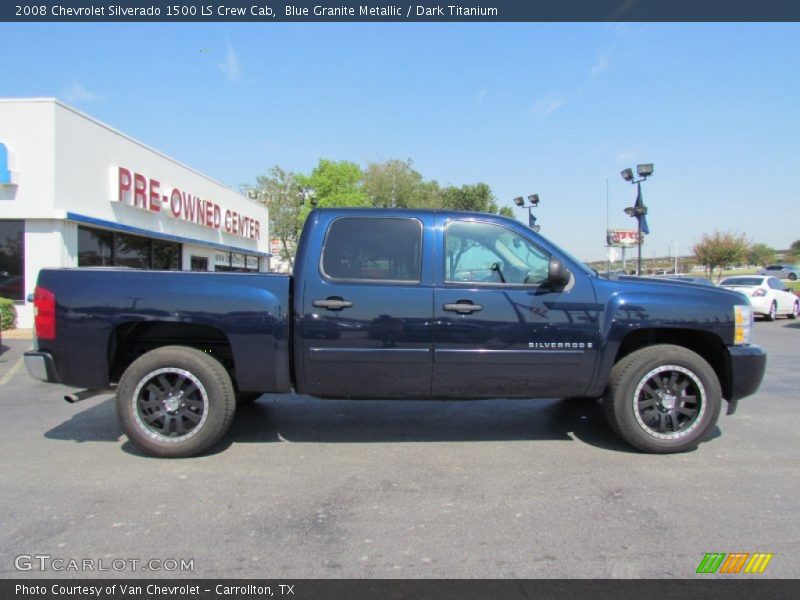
257, 165, 308, 267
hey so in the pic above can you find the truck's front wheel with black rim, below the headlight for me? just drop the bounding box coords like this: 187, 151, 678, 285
603, 344, 722, 454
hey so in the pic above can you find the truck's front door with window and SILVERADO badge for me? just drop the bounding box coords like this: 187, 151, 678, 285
433, 218, 600, 398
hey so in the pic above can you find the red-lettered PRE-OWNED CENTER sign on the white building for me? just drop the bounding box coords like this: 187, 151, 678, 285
112, 167, 261, 240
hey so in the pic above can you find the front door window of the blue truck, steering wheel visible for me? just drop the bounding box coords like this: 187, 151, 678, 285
445, 221, 550, 286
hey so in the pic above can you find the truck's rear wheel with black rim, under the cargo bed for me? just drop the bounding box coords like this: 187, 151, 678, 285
117, 346, 236, 458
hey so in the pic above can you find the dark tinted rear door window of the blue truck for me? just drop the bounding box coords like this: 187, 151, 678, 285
322, 217, 422, 282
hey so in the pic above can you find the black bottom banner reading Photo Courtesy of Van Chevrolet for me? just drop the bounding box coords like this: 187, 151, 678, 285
0, 577, 800, 600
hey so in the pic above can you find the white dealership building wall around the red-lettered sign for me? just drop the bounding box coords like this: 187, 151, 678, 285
0, 99, 270, 327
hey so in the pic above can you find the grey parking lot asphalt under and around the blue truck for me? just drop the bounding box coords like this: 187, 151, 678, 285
0, 319, 800, 578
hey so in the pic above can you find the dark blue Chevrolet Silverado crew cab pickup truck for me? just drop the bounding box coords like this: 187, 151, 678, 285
25, 209, 766, 457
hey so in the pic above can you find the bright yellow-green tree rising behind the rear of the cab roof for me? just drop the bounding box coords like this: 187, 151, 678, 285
297, 158, 370, 212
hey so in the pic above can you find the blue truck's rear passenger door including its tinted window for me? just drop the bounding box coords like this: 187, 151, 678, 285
295, 211, 433, 398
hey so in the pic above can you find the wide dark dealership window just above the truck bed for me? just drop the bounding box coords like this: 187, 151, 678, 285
78, 227, 181, 271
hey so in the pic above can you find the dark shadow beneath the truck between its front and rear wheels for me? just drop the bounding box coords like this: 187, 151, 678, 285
210, 395, 633, 453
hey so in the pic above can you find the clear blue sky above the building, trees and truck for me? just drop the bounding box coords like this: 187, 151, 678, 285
0, 23, 800, 260
